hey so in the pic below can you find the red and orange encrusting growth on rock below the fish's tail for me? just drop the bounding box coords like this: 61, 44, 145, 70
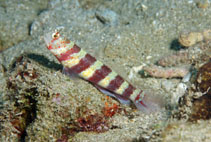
57, 100, 124, 142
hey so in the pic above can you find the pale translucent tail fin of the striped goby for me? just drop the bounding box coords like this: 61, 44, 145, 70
133, 91, 164, 114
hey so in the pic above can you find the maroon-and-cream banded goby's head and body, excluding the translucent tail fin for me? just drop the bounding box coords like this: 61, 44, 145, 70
45, 32, 160, 110
